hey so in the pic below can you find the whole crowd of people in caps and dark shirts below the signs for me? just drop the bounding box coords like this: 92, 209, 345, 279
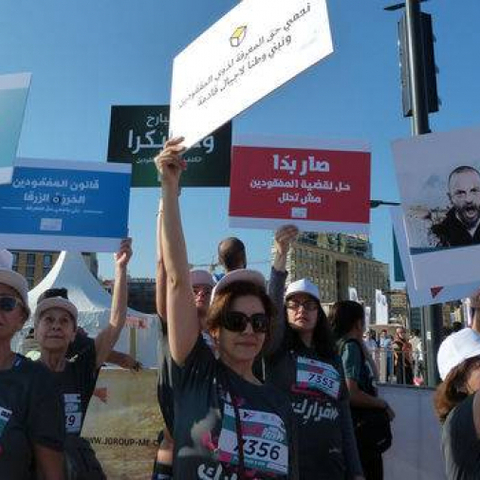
0, 138, 480, 480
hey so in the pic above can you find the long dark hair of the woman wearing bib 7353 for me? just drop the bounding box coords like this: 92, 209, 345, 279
285, 295, 337, 359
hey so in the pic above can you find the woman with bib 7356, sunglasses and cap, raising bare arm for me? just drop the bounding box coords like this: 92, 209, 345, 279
156, 138, 297, 480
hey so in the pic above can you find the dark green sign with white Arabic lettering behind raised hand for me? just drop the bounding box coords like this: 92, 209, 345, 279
107, 105, 232, 187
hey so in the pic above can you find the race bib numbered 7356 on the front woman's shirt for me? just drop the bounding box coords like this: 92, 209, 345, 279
218, 403, 288, 475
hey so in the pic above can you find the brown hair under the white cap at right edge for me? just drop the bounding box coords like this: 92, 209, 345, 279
433, 355, 480, 423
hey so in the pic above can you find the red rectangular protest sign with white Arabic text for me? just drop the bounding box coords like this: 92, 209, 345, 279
229, 139, 370, 233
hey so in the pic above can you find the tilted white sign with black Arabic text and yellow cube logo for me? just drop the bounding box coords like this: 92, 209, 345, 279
170, 0, 333, 148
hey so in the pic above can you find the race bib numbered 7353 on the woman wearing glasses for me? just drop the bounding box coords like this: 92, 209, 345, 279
297, 357, 341, 399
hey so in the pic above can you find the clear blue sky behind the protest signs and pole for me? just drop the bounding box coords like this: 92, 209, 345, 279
0, 0, 480, 284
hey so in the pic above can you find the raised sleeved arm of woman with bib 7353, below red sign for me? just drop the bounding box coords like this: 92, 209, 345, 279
265, 225, 298, 356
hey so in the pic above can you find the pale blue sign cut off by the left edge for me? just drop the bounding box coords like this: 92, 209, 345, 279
0, 73, 31, 185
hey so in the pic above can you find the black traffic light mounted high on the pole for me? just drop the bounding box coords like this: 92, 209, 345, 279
398, 12, 440, 117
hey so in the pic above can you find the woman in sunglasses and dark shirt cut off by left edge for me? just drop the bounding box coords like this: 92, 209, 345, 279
0, 250, 65, 480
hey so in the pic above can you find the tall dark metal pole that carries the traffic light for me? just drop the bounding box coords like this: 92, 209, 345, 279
387, 0, 443, 387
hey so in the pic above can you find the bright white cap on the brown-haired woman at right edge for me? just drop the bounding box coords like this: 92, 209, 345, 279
437, 328, 480, 380
